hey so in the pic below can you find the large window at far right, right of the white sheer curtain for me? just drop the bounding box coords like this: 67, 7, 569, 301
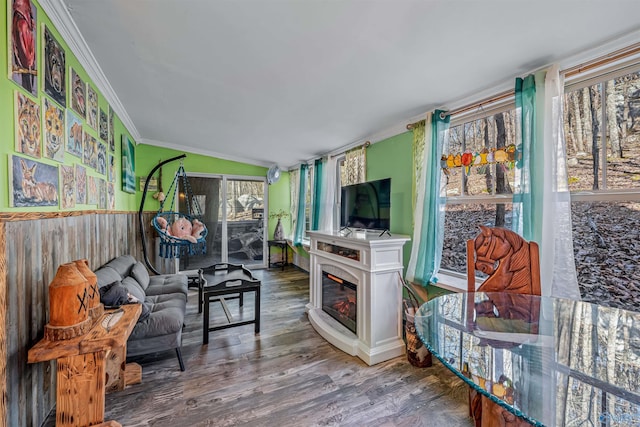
564, 63, 640, 310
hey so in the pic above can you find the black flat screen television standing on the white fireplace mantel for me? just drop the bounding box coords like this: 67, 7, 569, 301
340, 178, 391, 230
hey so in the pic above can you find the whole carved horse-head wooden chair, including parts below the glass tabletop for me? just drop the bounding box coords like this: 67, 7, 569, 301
467, 225, 541, 427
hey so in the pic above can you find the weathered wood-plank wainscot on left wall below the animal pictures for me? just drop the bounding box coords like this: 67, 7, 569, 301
0, 211, 153, 427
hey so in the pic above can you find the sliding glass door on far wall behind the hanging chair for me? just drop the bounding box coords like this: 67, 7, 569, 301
180, 174, 266, 271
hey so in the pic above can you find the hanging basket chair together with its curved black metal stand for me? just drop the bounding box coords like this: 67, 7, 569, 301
138, 154, 207, 274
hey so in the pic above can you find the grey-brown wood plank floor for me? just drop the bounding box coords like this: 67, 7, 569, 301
41, 266, 473, 427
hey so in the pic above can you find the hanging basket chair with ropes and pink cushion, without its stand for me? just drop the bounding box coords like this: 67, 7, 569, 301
151, 161, 207, 258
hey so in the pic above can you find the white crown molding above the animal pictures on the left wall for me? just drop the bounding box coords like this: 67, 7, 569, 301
38, 0, 141, 141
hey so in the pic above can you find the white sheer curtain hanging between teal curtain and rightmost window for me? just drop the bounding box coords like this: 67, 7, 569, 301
540, 65, 580, 299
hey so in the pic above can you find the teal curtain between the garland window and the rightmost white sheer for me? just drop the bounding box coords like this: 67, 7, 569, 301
511, 75, 544, 240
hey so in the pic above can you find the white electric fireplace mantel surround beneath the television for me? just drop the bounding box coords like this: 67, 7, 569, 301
307, 231, 410, 365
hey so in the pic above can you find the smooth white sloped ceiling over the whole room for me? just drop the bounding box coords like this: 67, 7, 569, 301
47, 0, 640, 171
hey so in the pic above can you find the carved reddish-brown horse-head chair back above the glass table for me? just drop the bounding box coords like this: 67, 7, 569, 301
467, 225, 541, 295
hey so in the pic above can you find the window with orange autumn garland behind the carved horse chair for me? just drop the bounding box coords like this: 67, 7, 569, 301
440, 106, 517, 277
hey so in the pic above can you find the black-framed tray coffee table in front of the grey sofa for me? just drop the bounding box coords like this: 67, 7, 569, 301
198, 263, 261, 345
